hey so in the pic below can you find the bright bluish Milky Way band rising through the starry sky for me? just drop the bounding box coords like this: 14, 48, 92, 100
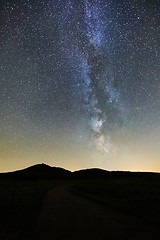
60, 0, 127, 153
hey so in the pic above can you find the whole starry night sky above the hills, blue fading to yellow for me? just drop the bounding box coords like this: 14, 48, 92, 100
0, 0, 160, 172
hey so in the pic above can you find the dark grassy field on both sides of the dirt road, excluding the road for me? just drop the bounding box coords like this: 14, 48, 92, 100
0, 174, 160, 240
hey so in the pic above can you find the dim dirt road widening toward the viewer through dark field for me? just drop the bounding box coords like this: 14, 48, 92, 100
34, 187, 154, 240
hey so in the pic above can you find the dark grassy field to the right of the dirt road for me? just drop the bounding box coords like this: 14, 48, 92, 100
71, 178, 160, 226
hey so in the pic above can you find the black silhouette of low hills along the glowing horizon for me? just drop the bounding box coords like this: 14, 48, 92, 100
0, 163, 160, 180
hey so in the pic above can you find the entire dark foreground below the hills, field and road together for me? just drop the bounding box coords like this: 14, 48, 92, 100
0, 164, 160, 240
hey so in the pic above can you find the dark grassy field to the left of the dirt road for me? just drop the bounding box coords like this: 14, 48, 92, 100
0, 180, 61, 240
